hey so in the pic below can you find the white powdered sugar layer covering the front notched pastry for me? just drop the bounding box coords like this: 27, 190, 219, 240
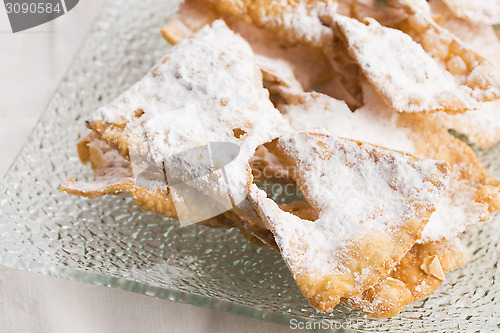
252, 132, 445, 278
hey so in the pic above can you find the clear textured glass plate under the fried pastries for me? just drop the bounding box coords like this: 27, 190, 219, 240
0, 0, 500, 332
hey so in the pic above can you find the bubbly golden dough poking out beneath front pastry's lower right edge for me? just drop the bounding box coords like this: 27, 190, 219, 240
342, 238, 468, 318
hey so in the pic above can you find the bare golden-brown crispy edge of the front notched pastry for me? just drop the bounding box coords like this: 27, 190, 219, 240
249, 133, 449, 312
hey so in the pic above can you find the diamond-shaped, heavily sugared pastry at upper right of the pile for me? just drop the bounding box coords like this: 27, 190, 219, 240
333, 15, 497, 113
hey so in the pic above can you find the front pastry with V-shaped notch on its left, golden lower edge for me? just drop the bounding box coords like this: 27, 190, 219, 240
249, 132, 448, 312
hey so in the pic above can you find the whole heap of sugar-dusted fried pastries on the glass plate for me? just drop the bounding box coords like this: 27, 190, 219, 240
62, 0, 500, 317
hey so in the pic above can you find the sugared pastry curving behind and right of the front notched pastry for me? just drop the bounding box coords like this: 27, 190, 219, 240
279, 84, 500, 317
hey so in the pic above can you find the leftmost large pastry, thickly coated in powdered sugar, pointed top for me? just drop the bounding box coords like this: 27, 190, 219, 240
87, 21, 289, 223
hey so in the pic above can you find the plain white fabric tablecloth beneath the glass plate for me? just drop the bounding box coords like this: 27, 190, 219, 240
0, 0, 300, 333
